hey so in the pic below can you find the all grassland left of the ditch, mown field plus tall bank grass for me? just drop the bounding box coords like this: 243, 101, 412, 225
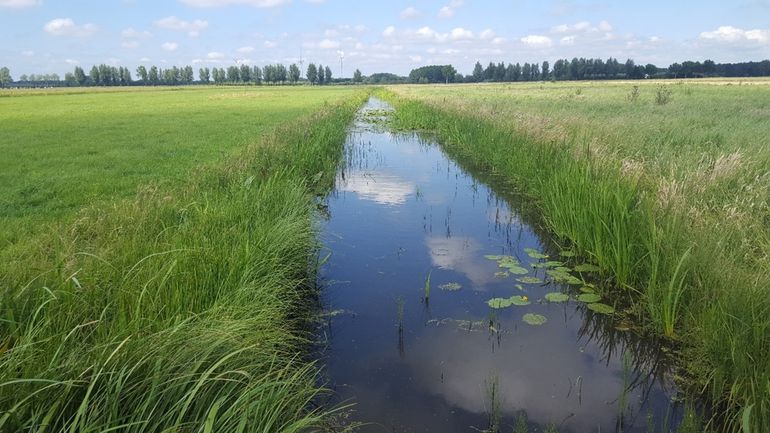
0, 88, 365, 432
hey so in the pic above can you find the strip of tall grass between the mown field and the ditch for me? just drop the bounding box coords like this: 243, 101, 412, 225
0, 89, 364, 432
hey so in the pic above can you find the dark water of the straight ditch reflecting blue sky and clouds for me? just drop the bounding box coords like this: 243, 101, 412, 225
321, 99, 680, 433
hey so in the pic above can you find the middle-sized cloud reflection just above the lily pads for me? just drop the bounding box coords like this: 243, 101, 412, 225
425, 236, 495, 290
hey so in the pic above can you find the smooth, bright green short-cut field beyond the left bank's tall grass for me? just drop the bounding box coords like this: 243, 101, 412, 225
0, 87, 352, 249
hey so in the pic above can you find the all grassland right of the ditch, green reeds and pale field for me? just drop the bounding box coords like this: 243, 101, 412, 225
382, 81, 770, 431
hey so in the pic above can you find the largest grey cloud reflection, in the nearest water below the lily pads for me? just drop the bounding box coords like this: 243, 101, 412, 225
407, 314, 636, 432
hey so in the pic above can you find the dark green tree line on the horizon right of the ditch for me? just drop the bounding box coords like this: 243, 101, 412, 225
408, 57, 770, 83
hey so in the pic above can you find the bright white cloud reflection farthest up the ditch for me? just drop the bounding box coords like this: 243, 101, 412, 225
337, 171, 415, 206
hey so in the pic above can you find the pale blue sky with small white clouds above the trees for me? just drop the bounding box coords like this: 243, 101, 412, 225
0, 0, 770, 78
